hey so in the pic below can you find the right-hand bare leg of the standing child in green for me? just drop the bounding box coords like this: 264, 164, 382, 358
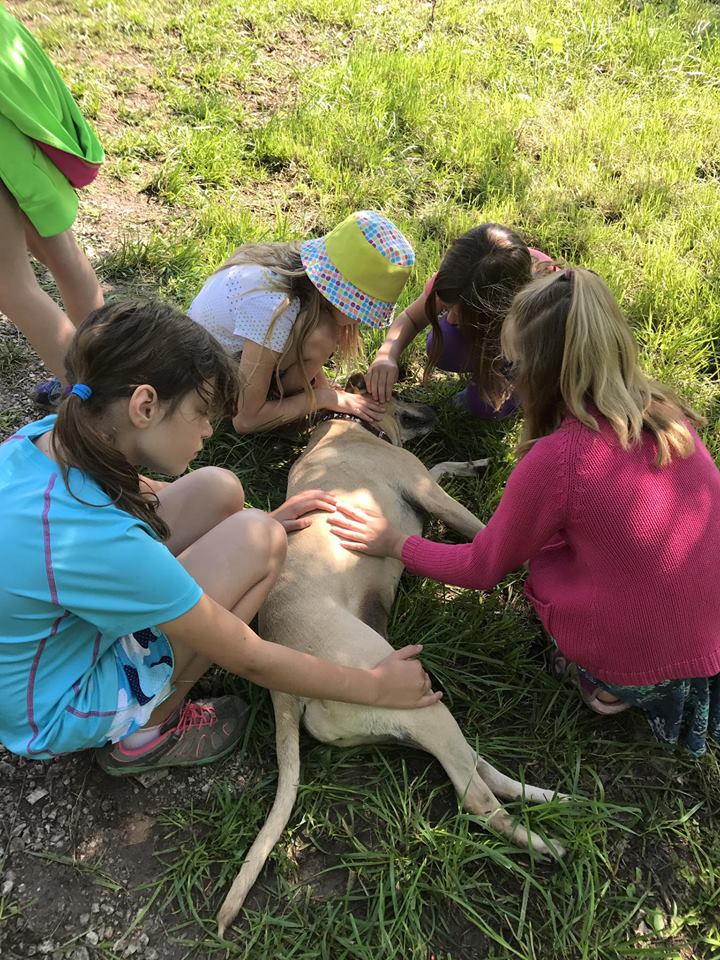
23, 214, 105, 327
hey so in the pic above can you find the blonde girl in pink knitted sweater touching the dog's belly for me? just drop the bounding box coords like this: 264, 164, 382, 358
329, 269, 720, 755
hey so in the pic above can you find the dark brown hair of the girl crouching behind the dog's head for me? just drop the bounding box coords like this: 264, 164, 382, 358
425, 223, 532, 408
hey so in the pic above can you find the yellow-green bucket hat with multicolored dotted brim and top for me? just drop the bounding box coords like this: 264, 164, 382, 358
300, 210, 415, 328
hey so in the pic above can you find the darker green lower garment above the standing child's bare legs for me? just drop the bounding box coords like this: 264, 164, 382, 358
0, 114, 78, 237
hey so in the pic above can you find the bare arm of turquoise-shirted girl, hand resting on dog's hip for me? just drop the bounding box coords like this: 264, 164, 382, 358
160, 594, 441, 709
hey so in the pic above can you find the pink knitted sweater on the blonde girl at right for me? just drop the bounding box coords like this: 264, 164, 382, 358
402, 418, 720, 685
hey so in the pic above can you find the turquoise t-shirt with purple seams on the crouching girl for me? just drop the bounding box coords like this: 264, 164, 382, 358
0, 416, 202, 759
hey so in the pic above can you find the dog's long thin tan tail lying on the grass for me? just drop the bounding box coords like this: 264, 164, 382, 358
217, 693, 300, 936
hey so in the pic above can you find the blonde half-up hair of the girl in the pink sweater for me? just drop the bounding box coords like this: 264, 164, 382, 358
501, 269, 702, 467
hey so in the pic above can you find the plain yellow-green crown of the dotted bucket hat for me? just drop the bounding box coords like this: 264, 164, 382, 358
325, 214, 410, 303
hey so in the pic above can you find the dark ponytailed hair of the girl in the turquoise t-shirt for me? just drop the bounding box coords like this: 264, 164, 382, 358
53, 301, 238, 540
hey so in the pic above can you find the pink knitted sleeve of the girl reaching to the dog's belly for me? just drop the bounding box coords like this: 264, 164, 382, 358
402, 428, 568, 590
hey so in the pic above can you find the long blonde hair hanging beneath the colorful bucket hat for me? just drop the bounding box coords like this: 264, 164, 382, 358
215, 241, 362, 410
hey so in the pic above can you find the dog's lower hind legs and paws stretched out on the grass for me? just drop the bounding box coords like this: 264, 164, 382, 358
404, 704, 565, 856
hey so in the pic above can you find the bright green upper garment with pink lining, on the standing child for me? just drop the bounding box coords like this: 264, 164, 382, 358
0, 6, 104, 163
